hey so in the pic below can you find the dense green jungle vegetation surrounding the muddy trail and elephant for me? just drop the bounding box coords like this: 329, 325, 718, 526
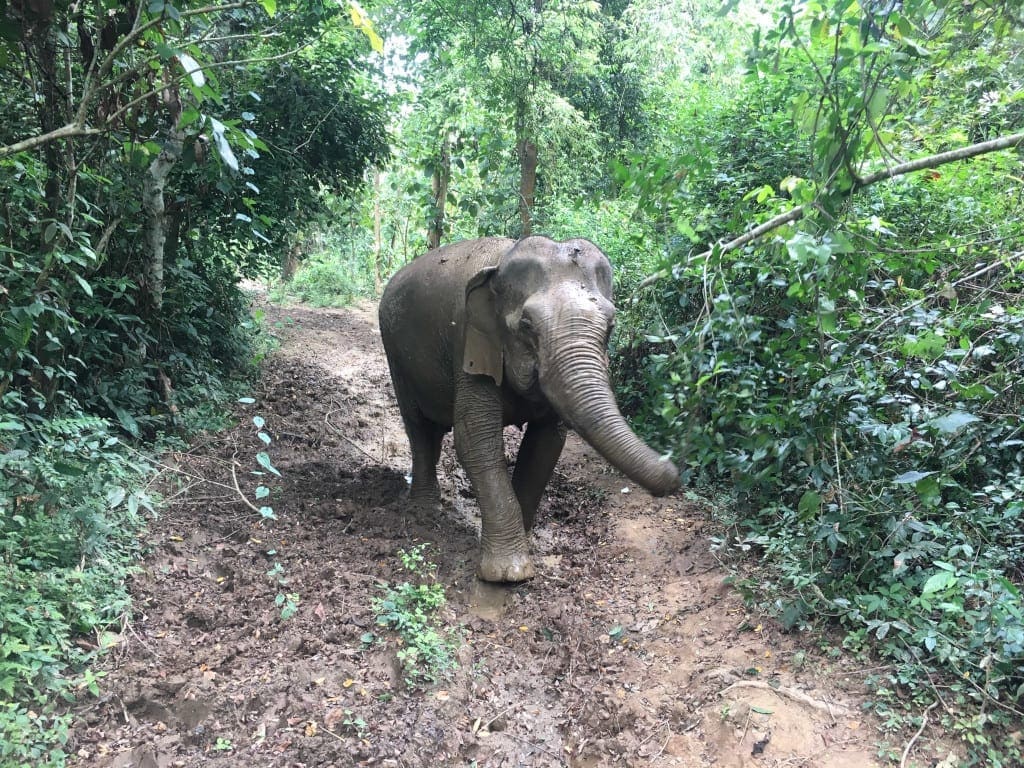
0, 0, 1024, 766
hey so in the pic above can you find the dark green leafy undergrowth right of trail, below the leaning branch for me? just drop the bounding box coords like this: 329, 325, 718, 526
624, 222, 1024, 766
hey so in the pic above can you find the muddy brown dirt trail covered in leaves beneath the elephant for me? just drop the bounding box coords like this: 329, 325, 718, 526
72, 305, 878, 768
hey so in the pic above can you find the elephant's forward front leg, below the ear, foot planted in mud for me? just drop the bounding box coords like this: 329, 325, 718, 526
455, 376, 535, 582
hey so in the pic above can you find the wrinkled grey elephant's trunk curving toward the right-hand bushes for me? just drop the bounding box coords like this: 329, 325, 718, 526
540, 316, 679, 496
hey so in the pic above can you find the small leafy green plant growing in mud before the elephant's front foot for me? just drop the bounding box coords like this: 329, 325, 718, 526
374, 544, 456, 686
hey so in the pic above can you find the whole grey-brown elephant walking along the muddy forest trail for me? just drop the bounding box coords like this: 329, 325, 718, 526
379, 236, 679, 582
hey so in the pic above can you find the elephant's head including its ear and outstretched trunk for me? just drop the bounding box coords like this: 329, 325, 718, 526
463, 237, 679, 496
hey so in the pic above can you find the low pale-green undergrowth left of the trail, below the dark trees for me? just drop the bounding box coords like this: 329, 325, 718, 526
0, 417, 152, 766
